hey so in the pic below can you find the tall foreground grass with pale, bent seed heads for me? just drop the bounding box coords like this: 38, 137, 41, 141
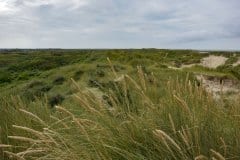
0, 67, 240, 160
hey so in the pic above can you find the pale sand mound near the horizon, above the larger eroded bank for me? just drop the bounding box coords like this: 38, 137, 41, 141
201, 55, 228, 68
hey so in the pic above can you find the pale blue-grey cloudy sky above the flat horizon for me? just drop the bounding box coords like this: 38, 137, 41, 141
0, 0, 240, 50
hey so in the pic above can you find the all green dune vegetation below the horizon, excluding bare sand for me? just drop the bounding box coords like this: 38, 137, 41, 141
0, 49, 240, 160
